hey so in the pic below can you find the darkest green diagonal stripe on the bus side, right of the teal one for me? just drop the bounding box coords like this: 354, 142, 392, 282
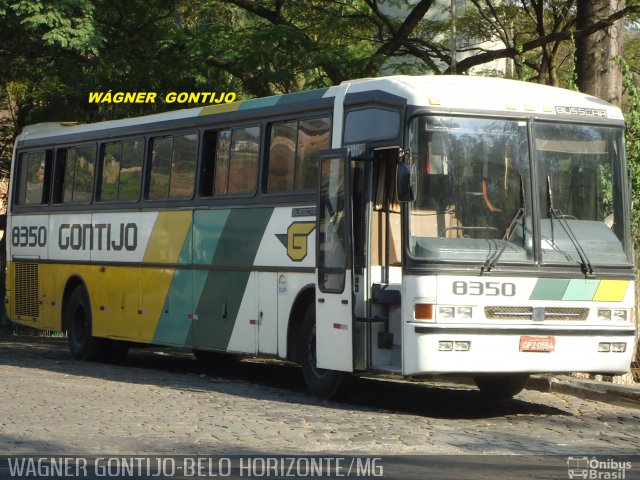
191, 208, 273, 350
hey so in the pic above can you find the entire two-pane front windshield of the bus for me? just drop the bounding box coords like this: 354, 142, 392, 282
409, 115, 628, 264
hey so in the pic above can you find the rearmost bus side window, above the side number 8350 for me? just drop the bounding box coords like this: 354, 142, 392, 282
15, 151, 51, 205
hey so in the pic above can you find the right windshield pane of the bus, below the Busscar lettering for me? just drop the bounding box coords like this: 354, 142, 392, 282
533, 123, 628, 264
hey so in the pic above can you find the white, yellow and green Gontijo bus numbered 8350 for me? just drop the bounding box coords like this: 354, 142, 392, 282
6, 76, 636, 398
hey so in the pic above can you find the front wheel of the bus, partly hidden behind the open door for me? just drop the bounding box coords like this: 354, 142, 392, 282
300, 303, 351, 400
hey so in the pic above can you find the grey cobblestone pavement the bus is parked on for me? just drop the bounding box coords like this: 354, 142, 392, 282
0, 337, 640, 455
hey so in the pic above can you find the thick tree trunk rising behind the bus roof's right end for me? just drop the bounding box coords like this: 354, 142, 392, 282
576, 0, 626, 106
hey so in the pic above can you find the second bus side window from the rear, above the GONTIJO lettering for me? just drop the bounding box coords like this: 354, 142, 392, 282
62, 146, 96, 203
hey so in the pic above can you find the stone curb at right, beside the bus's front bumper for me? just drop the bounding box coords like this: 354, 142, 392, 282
525, 375, 640, 408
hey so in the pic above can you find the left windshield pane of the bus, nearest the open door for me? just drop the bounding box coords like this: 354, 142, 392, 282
409, 116, 533, 262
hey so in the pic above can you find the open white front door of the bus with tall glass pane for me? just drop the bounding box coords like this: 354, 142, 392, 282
316, 149, 354, 372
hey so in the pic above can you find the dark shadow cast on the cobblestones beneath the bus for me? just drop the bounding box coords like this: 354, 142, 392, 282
0, 335, 572, 419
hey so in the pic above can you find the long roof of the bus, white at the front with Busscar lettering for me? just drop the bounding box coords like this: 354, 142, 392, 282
16, 75, 623, 142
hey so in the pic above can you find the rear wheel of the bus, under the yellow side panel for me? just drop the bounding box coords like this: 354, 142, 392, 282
65, 286, 105, 360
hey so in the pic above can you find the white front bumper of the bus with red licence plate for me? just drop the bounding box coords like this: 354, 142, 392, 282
403, 322, 636, 375
